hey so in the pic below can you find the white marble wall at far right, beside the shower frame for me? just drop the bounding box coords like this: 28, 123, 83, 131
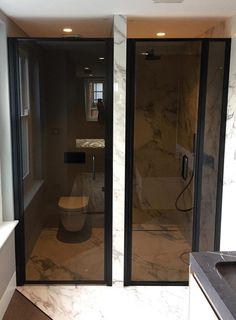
202, 16, 236, 251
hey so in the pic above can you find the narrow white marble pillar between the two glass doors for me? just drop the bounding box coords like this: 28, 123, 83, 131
112, 15, 127, 282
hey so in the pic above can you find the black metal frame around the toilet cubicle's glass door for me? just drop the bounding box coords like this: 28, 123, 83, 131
8, 37, 113, 286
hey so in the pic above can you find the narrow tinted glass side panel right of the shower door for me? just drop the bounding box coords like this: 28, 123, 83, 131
199, 41, 225, 251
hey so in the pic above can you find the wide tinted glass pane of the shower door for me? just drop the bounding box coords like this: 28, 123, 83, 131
131, 41, 201, 281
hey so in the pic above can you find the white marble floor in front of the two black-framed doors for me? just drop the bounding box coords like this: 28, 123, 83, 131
18, 283, 189, 320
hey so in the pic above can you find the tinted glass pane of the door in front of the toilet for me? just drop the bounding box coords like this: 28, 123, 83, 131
19, 40, 106, 281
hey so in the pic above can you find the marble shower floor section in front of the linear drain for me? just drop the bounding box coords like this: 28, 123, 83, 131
132, 229, 191, 281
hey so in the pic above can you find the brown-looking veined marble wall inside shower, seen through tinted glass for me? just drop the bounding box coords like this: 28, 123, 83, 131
134, 43, 200, 210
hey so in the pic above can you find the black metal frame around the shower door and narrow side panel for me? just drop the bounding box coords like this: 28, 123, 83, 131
124, 38, 231, 286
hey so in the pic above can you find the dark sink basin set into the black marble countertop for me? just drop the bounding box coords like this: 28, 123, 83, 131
216, 261, 236, 293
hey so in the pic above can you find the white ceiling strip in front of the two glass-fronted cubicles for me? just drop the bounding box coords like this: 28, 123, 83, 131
0, 0, 236, 18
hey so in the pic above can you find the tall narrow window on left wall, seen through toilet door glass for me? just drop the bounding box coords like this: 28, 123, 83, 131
19, 52, 30, 179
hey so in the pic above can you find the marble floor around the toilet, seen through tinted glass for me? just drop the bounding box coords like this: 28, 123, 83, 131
26, 228, 104, 280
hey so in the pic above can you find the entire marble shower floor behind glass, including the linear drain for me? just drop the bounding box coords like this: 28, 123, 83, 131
132, 208, 192, 281
